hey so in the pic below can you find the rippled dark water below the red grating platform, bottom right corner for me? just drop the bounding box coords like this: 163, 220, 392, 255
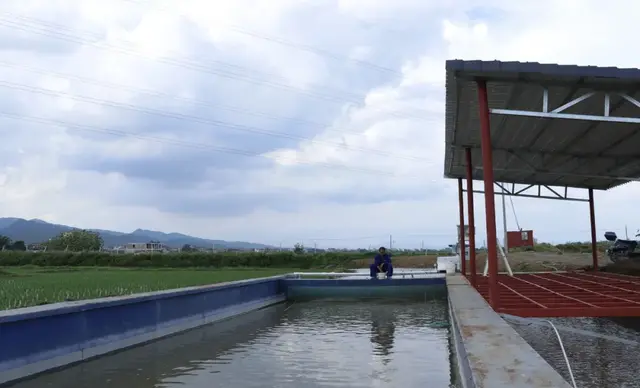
509, 318, 640, 388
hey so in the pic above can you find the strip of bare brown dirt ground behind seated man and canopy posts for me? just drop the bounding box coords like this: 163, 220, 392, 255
353, 252, 608, 274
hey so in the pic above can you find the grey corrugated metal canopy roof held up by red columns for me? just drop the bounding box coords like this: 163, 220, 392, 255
444, 60, 640, 190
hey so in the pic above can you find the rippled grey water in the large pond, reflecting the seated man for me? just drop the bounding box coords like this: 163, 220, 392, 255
8, 300, 452, 388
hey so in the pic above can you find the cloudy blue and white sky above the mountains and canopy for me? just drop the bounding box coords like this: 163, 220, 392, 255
0, 0, 640, 248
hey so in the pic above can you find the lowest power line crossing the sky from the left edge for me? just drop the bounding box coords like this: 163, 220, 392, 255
0, 111, 412, 177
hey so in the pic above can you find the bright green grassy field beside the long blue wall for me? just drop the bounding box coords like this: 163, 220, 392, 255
0, 267, 308, 310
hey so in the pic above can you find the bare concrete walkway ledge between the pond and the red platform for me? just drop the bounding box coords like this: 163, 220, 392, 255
447, 274, 571, 388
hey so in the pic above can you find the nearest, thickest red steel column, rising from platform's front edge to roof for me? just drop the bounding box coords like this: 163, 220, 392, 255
477, 80, 500, 310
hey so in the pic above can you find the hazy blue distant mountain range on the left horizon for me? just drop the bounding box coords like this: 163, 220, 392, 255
0, 218, 269, 249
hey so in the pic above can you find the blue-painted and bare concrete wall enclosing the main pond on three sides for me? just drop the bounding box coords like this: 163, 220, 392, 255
0, 275, 569, 388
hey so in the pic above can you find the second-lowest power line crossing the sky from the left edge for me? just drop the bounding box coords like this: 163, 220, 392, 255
0, 81, 429, 162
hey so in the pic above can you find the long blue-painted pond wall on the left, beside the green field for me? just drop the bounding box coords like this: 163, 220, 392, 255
0, 276, 285, 384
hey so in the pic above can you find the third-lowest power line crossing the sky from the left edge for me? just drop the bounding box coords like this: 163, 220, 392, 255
0, 60, 440, 139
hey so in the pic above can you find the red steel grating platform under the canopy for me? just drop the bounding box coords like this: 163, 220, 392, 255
476, 272, 640, 317
